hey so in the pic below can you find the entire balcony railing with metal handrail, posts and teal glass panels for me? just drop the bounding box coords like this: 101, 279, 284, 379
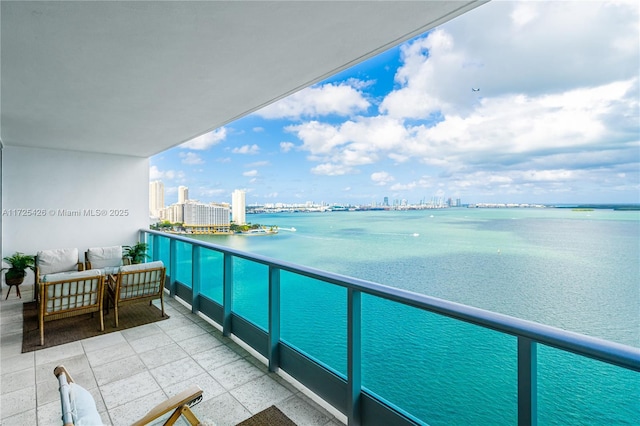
140, 230, 640, 426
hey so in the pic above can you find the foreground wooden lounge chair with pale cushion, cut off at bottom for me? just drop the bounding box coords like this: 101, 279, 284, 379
53, 365, 202, 426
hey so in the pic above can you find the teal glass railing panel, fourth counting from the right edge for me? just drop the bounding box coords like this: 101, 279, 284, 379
232, 257, 269, 331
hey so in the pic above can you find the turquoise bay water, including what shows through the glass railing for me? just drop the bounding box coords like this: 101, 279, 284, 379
171, 209, 640, 425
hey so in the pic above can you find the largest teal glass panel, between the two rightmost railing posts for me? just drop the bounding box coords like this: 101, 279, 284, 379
362, 295, 518, 426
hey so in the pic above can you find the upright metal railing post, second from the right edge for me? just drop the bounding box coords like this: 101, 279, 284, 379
347, 288, 362, 426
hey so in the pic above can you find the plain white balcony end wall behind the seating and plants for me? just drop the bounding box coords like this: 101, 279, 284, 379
2, 146, 149, 282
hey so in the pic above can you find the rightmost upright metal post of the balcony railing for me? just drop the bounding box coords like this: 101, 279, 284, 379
518, 336, 538, 426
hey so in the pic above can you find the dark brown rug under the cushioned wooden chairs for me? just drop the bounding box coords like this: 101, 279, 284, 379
22, 302, 169, 353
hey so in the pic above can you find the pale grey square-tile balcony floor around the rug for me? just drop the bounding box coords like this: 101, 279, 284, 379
0, 285, 346, 426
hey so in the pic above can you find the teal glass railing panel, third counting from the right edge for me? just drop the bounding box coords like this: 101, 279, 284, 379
280, 271, 347, 376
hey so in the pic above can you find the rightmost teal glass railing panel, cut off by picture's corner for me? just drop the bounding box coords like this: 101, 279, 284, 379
538, 345, 640, 426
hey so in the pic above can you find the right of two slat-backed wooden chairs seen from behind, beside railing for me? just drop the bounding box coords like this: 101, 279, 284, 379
107, 260, 166, 327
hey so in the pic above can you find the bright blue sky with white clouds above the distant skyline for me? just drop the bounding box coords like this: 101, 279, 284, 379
150, 1, 640, 204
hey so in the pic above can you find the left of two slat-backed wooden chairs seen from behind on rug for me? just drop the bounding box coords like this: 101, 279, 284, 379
37, 269, 104, 345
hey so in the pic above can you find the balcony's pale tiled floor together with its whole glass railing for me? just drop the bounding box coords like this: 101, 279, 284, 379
1, 230, 640, 425
